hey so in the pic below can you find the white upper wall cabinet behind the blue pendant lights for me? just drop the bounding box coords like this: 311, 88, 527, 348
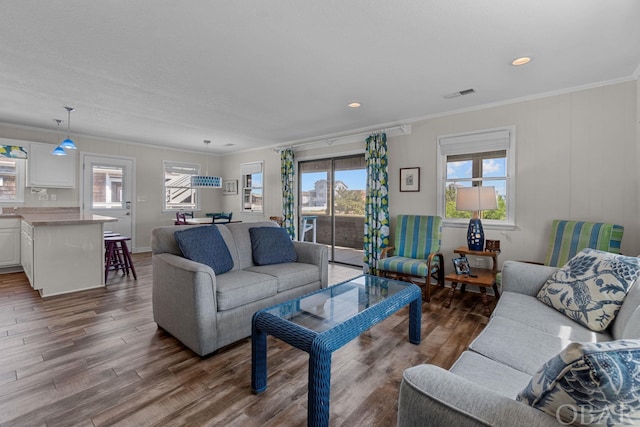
27, 142, 78, 188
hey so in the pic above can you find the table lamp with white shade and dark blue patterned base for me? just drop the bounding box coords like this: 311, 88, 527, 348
456, 186, 498, 251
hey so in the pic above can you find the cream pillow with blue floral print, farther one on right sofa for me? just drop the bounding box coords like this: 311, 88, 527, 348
538, 249, 640, 331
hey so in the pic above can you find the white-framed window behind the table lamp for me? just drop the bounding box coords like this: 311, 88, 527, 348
438, 128, 515, 228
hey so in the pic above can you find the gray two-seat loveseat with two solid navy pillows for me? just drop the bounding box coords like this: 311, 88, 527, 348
151, 222, 328, 356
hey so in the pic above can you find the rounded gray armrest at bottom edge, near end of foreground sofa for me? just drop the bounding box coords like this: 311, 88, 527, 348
398, 365, 560, 427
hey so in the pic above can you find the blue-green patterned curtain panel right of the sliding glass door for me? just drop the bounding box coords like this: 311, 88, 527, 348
364, 133, 389, 274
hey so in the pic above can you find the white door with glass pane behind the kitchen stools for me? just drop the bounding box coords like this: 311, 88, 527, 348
82, 154, 136, 249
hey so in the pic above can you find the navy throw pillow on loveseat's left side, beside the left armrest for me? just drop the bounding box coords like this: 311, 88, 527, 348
173, 225, 233, 274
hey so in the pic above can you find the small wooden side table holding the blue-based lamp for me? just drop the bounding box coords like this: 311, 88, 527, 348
444, 246, 500, 316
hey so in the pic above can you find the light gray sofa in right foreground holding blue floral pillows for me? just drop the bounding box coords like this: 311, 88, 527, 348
398, 261, 640, 427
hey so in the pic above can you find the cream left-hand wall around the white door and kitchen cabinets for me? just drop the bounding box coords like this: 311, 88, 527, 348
0, 125, 222, 251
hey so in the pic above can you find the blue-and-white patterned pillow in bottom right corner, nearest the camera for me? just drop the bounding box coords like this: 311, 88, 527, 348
516, 340, 640, 426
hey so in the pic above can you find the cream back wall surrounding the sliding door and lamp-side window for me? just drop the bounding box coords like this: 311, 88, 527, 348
223, 81, 640, 264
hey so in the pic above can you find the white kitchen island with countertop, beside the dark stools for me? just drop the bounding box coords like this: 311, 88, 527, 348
10, 209, 117, 297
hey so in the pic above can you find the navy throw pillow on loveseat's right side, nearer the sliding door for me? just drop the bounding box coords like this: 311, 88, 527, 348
249, 227, 298, 265
